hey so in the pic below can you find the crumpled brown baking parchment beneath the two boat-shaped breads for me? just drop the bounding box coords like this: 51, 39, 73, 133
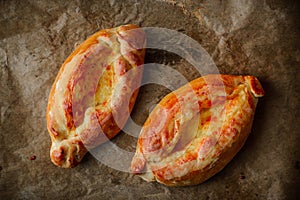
0, 0, 300, 199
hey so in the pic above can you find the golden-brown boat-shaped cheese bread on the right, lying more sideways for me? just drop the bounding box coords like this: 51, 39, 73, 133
131, 75, 264, 186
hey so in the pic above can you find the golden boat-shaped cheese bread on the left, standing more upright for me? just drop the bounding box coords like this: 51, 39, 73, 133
47, 25, 145, 168
